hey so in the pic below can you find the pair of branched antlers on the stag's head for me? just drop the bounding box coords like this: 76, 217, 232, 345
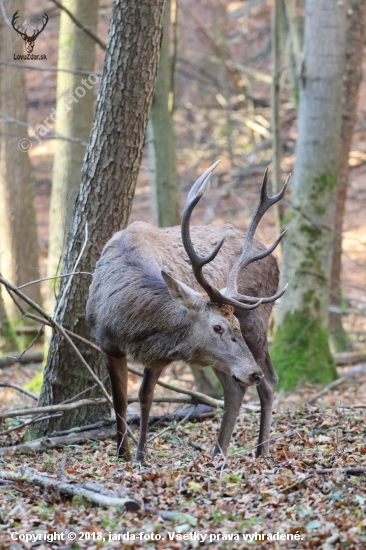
181, 161, 290, 309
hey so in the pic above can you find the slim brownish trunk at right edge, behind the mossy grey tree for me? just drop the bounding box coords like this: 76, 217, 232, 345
329, 0, 366, 351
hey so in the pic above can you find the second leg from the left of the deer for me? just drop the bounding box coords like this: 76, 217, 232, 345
135, 367, 164, 462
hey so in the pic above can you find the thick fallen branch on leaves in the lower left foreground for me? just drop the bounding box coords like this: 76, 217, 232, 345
0, 470, 142, 511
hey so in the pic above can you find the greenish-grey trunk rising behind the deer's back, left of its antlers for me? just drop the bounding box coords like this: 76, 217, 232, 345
151, 0, 179, 227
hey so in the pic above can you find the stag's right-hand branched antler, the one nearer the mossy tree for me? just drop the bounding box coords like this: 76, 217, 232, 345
225, 168, 290, 303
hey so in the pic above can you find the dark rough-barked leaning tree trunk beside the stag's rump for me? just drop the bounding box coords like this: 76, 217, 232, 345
37, 0, 164, 440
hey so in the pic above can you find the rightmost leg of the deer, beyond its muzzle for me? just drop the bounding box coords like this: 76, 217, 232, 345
256, 352, 278, 457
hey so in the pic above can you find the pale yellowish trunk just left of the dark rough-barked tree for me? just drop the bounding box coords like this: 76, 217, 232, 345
48, 0, 98, 312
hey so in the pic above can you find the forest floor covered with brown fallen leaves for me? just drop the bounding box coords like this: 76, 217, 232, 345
0, 366, 366, 550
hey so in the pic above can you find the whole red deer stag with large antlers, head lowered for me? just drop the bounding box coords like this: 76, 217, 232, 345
87, 162, 288, 461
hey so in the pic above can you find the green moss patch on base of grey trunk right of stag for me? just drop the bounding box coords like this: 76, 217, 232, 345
271, 310, 337, 390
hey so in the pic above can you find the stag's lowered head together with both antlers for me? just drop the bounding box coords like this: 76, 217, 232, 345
162, 162, 289, 386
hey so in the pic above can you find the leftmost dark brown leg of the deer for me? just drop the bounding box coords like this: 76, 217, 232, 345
106, 352, 131, 461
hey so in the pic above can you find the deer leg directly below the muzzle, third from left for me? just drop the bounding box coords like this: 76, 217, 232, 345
214, 369, 246, 456
